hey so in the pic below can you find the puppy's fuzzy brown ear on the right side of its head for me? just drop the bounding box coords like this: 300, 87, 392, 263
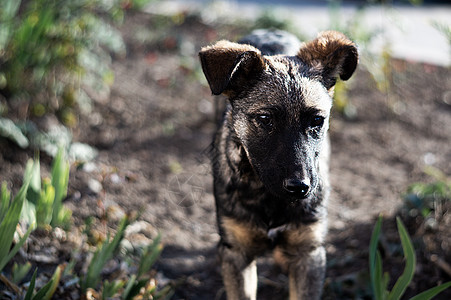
297, 31, 359, 89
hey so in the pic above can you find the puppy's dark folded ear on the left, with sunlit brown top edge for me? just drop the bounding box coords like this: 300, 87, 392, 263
199, 41, 265, 95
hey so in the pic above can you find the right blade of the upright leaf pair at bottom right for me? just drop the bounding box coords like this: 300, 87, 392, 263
388, 217, 416, 300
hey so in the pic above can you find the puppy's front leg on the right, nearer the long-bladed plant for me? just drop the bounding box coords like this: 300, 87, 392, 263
288, 247, 326, 300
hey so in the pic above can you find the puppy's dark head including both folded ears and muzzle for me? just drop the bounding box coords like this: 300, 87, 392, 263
199, 31, 358, 205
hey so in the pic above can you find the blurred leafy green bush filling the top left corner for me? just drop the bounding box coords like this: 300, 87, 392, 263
0, 0, 131, 154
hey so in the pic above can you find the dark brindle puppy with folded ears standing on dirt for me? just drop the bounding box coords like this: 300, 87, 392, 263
200, 31, 358, 299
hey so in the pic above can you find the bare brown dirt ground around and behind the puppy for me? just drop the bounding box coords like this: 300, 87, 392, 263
0, 13, 451, 299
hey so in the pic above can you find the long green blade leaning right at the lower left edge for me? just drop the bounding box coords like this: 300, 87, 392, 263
0, 171, 31, 272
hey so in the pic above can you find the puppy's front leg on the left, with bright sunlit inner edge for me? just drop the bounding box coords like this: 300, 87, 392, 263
219, 246, 257, 300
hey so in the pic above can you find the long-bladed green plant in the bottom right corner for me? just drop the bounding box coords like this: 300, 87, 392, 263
369, 216, 451, 300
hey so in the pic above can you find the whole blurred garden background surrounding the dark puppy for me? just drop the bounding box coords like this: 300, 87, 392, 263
0, 0, 451, 299
